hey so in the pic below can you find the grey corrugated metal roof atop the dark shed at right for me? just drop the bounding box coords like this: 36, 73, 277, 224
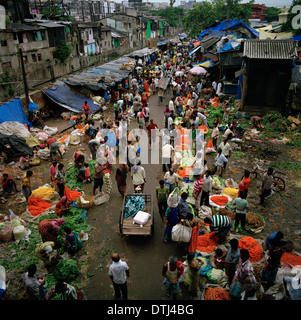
243, 39, 298, 60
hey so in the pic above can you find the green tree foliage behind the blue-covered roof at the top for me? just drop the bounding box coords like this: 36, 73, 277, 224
183, 0, 254, 37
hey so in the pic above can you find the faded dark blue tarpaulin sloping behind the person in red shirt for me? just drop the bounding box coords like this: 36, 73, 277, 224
42, 84, 99, 112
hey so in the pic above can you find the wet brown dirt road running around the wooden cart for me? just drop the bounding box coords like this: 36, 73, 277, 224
79, 88, 193, 300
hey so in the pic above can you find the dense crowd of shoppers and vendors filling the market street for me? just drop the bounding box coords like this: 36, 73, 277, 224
2, 36, 301, 300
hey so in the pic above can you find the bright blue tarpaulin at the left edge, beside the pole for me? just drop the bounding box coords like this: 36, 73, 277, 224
0, 99, 32, 128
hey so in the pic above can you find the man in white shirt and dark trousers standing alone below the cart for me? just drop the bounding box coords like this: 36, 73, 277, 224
108, 253, 130, 300
